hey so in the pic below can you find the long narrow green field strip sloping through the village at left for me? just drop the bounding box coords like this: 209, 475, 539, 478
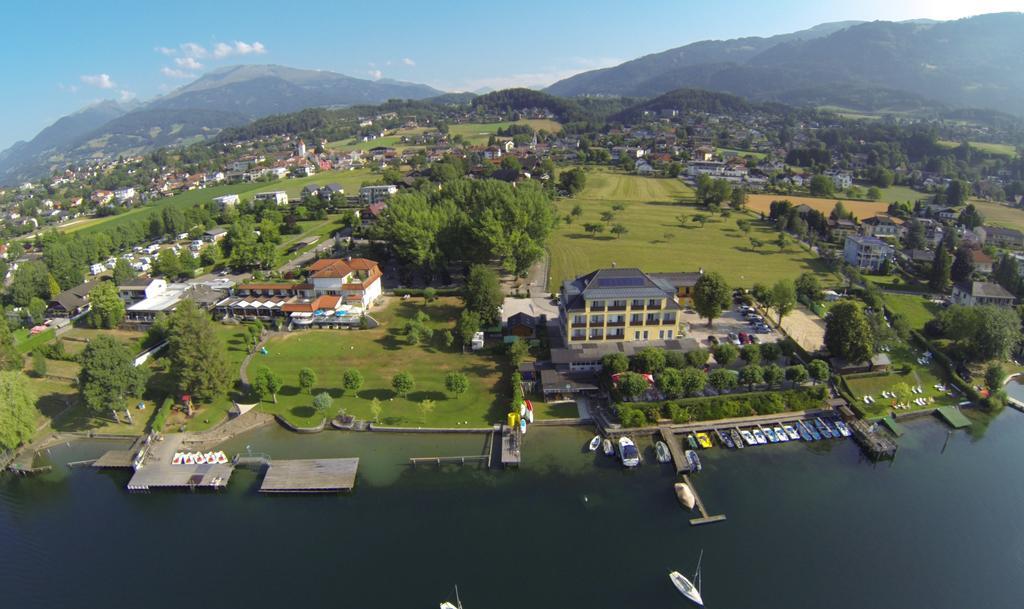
60, 169, 375, 239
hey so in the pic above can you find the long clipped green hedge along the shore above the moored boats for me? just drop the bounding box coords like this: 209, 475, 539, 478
615, 385, 827, 427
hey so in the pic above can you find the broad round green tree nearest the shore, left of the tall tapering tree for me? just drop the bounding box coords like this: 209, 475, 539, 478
78, 335, 150, 412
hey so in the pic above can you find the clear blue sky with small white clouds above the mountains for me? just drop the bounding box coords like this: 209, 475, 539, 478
0, 0, 1024, 149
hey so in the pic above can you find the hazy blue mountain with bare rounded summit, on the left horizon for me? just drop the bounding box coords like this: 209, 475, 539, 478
0, 64, 442, 183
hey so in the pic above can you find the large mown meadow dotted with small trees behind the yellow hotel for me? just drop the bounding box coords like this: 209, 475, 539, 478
549, 169, 834, 290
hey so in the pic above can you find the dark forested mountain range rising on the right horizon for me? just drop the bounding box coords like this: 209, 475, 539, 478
546, 13, 1024, 116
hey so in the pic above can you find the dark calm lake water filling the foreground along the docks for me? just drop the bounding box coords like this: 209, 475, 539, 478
0, 409, 1024, 609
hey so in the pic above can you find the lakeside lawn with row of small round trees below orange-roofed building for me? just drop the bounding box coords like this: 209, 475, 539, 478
240, 298, 508, 427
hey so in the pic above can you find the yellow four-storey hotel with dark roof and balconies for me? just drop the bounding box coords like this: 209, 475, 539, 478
559, 268, 682, 346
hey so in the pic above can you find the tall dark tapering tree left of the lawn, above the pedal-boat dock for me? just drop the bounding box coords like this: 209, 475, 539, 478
167, 299, 233, 400
